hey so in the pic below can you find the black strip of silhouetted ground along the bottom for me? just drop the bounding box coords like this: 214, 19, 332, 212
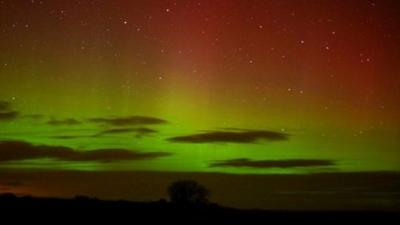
0, 194, 400, 225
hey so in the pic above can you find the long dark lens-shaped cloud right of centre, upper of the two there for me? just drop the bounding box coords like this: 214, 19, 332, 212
167, 130, 289, 143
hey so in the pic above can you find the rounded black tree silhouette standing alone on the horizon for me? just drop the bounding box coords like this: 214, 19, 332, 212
168, 180, 210, 205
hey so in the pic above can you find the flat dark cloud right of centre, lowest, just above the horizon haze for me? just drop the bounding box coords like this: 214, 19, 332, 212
210, 158, 336, 168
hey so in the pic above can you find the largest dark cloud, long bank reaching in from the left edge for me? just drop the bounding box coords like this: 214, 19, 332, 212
0, 141, 171, 162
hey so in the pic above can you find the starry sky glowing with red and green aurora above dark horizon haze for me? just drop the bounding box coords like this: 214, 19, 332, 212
0, 0, 400, 210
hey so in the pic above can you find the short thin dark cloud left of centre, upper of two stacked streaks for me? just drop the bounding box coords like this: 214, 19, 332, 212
89, 116, 167, 126
